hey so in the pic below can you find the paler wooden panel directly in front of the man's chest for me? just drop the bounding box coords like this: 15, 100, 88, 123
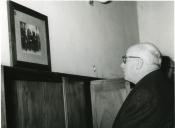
91, 79, 127, 128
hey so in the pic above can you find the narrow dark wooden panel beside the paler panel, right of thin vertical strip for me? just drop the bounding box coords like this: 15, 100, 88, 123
64, 79, 92, 128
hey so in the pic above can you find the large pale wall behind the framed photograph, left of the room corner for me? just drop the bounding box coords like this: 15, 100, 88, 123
0, 0, 139, 78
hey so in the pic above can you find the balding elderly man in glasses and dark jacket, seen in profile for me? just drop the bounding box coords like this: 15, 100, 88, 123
113, 43, 174, 128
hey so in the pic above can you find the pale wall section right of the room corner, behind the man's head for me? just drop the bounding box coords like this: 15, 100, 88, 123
137, 1, 175, 60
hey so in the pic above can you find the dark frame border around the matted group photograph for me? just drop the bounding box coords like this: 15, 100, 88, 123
7, 1, 51, 71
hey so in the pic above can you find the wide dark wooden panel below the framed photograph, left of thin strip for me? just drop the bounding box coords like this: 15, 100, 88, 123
6, 80, 65, 128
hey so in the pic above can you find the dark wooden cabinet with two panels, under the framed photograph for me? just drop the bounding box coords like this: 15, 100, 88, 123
1, 66, 93, 128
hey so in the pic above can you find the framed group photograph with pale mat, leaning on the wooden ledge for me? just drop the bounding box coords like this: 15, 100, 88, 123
8, 1, 51, 71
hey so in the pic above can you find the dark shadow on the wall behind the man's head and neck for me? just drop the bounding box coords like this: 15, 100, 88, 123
161, 56, 174, 84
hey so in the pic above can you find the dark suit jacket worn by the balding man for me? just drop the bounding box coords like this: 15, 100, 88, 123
113, 70, 174, 128
